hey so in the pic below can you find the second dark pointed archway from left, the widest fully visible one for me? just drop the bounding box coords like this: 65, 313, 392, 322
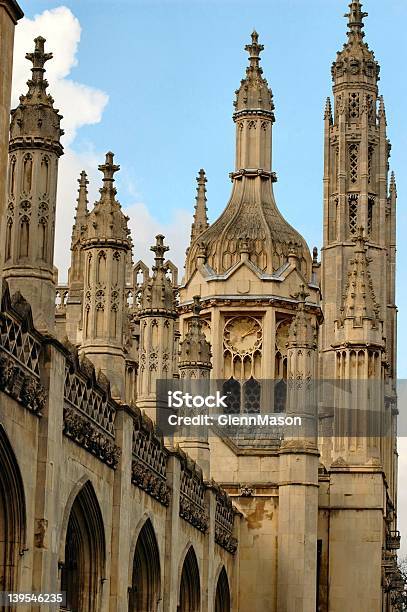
61, 481, 105, 612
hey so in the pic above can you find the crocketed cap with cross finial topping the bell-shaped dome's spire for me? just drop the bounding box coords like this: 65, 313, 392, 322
234, 30, 274, 120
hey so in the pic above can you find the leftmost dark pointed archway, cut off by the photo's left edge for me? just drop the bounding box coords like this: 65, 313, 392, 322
0, 426, 26, 591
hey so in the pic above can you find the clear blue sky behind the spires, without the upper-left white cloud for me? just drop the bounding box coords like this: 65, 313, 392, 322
18, 0, 407, 544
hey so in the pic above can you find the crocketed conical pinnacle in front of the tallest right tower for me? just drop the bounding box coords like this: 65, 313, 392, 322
343, 227, 379, 321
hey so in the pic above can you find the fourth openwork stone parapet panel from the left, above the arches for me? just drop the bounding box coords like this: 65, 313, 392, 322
178, 450, 209, 533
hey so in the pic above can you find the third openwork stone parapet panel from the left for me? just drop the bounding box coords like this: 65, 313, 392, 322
131, 408, 171, 506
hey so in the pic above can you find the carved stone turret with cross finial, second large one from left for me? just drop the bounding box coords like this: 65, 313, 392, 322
77, 152, 131, 399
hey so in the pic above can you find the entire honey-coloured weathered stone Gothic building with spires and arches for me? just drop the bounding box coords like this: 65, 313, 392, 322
0, 0, 400, 612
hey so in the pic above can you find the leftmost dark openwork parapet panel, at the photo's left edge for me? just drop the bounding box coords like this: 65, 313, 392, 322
0, 289, 46, 416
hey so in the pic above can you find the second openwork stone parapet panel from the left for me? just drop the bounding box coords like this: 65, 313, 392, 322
64, 343, 120, 468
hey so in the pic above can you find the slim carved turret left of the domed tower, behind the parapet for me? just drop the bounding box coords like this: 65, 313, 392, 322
137, 235, 178, 419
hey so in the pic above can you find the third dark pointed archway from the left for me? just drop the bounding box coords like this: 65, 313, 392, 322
129, 519, 161, 612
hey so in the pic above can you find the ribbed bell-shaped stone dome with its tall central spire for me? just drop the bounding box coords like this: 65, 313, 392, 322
186, 32, 311, 280
